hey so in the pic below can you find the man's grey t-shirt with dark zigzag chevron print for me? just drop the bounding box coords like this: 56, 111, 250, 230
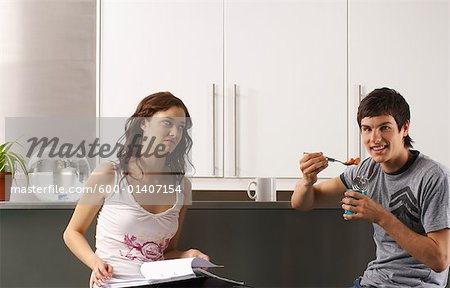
340, 150, 450, 287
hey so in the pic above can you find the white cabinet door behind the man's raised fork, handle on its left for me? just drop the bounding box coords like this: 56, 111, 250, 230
224, 0, 349, 177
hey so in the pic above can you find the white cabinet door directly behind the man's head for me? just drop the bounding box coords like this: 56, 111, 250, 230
349, 0, 450, 166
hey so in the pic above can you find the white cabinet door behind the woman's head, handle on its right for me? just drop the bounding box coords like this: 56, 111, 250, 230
100, 0, 223, 176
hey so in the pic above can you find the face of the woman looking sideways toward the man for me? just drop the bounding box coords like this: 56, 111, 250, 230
141, 106, 186, 155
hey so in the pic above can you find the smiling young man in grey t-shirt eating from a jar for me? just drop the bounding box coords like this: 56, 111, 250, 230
291, 88, 450, 287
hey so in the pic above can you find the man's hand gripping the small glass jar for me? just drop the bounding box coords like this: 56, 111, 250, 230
342, 190, 389, 224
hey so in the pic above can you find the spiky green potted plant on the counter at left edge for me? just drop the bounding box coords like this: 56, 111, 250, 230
0, 141, 28, 201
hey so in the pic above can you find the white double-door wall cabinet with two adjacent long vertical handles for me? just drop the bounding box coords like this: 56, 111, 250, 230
100, 0, 348, 180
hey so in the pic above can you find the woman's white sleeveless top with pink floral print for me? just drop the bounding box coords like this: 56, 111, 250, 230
95, 165, 184, 279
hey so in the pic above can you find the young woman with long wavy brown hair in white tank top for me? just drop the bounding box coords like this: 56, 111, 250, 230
64, 92, 209, 288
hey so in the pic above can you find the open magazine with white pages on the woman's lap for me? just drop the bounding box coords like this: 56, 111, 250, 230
102, 258, 244, 288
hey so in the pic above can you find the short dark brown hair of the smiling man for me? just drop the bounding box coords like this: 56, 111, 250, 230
357, 87, 414, 148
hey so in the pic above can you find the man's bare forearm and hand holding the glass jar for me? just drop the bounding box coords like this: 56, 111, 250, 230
342, 191, 450, 272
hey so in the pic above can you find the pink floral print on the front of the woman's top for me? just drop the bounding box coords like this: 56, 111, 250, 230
119, 234, 170, 262
